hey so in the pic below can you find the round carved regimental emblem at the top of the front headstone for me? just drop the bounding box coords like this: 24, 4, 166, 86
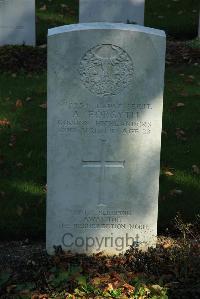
80, 44, 133, 96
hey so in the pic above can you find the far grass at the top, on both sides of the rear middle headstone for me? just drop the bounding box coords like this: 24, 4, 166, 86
36, 0, 199, 44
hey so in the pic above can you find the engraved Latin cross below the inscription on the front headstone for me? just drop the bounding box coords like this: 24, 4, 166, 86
82, 140, 125, 206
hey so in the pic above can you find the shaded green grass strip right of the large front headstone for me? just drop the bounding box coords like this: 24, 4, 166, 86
159, 66, 200, 227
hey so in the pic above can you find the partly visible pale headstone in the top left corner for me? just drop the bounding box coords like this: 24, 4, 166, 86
0, 0, 35, 46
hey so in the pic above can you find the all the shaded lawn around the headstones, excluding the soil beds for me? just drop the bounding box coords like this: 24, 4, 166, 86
0, 0, 200, 237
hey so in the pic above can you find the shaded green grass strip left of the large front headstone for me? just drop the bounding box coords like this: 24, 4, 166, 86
0, 74, 46, 236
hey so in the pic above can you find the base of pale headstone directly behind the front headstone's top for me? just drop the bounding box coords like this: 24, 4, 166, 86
79, 0, 145, 25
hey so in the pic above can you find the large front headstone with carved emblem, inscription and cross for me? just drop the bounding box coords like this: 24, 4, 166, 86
47, 23, 165, 254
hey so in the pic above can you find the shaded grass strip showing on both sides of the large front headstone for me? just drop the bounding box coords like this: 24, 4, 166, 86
0, 66, 200, 237
